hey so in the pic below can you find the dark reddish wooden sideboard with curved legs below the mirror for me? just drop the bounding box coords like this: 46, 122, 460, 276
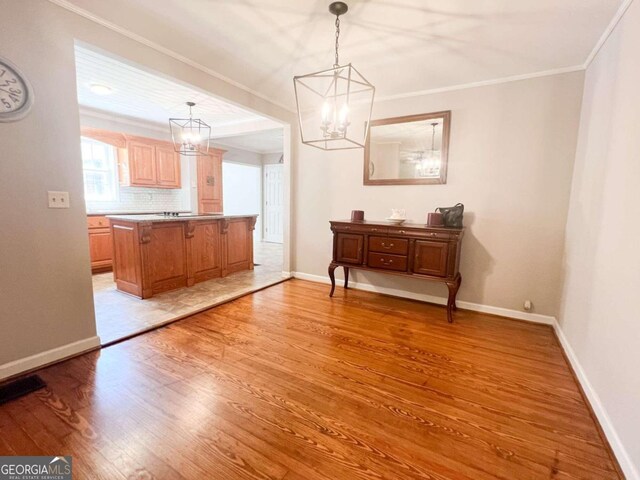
329, 220, 464, 323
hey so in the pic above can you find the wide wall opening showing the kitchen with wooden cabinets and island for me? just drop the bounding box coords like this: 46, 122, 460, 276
76, 44, 288, 345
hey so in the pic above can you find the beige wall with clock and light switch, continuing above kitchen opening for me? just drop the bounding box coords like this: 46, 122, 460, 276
0, 0, 294, 378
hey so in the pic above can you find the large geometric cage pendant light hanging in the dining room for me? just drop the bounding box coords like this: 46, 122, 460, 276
293, 2, 375, 150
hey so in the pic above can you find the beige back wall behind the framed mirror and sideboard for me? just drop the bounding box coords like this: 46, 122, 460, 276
294, 72, 583, 316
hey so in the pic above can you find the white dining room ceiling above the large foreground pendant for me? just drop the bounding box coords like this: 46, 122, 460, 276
61, 0, 622, 107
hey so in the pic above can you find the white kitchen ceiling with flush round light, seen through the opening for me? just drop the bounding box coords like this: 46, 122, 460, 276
75, 46, 279, 133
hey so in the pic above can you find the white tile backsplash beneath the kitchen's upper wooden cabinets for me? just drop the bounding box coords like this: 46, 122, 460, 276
87, 187, 190, 213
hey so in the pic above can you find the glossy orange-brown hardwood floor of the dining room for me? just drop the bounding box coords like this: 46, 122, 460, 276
0, 280, 622, 480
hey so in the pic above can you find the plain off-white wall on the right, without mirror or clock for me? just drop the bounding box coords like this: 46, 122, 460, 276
560, 2, 640, 479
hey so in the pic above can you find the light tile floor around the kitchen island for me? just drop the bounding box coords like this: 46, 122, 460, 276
93, 242, 286, 345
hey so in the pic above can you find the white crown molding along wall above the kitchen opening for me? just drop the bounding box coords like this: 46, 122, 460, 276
49, 0, 295, 113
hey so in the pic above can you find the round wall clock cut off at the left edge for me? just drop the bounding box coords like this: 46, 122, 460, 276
0, 57, 33, 122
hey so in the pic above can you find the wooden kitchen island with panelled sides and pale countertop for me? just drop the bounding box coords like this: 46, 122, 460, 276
107, 214, 258, 299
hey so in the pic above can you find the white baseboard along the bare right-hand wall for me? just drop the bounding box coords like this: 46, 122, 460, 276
553, 322, 640, 480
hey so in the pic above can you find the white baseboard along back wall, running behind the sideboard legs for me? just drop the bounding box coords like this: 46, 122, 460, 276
291, 272, 556, 325
